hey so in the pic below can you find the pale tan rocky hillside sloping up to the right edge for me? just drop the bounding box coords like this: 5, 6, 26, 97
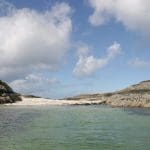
67, 80, 150, 107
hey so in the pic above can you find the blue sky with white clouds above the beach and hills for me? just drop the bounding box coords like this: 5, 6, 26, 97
0, 0, 150, 99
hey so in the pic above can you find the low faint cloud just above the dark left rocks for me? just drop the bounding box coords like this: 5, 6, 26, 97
10, 74, 60, 96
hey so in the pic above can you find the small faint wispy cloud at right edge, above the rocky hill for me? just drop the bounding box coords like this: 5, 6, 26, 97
129, 58, 150, 68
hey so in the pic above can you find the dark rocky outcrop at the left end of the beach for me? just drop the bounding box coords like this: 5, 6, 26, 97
0, 80, 21, 104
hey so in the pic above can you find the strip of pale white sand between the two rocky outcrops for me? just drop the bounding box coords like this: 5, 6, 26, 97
5, 97, 102, 106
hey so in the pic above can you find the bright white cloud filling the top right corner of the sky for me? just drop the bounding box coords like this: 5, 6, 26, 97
88, 0, 150, 34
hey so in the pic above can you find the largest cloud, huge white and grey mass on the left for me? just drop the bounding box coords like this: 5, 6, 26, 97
0, 0, 72, 79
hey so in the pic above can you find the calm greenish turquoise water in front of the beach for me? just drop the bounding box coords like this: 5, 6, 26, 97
0, 106, 150, 150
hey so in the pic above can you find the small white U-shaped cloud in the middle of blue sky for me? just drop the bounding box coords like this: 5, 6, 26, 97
73, 42, 121, 77
